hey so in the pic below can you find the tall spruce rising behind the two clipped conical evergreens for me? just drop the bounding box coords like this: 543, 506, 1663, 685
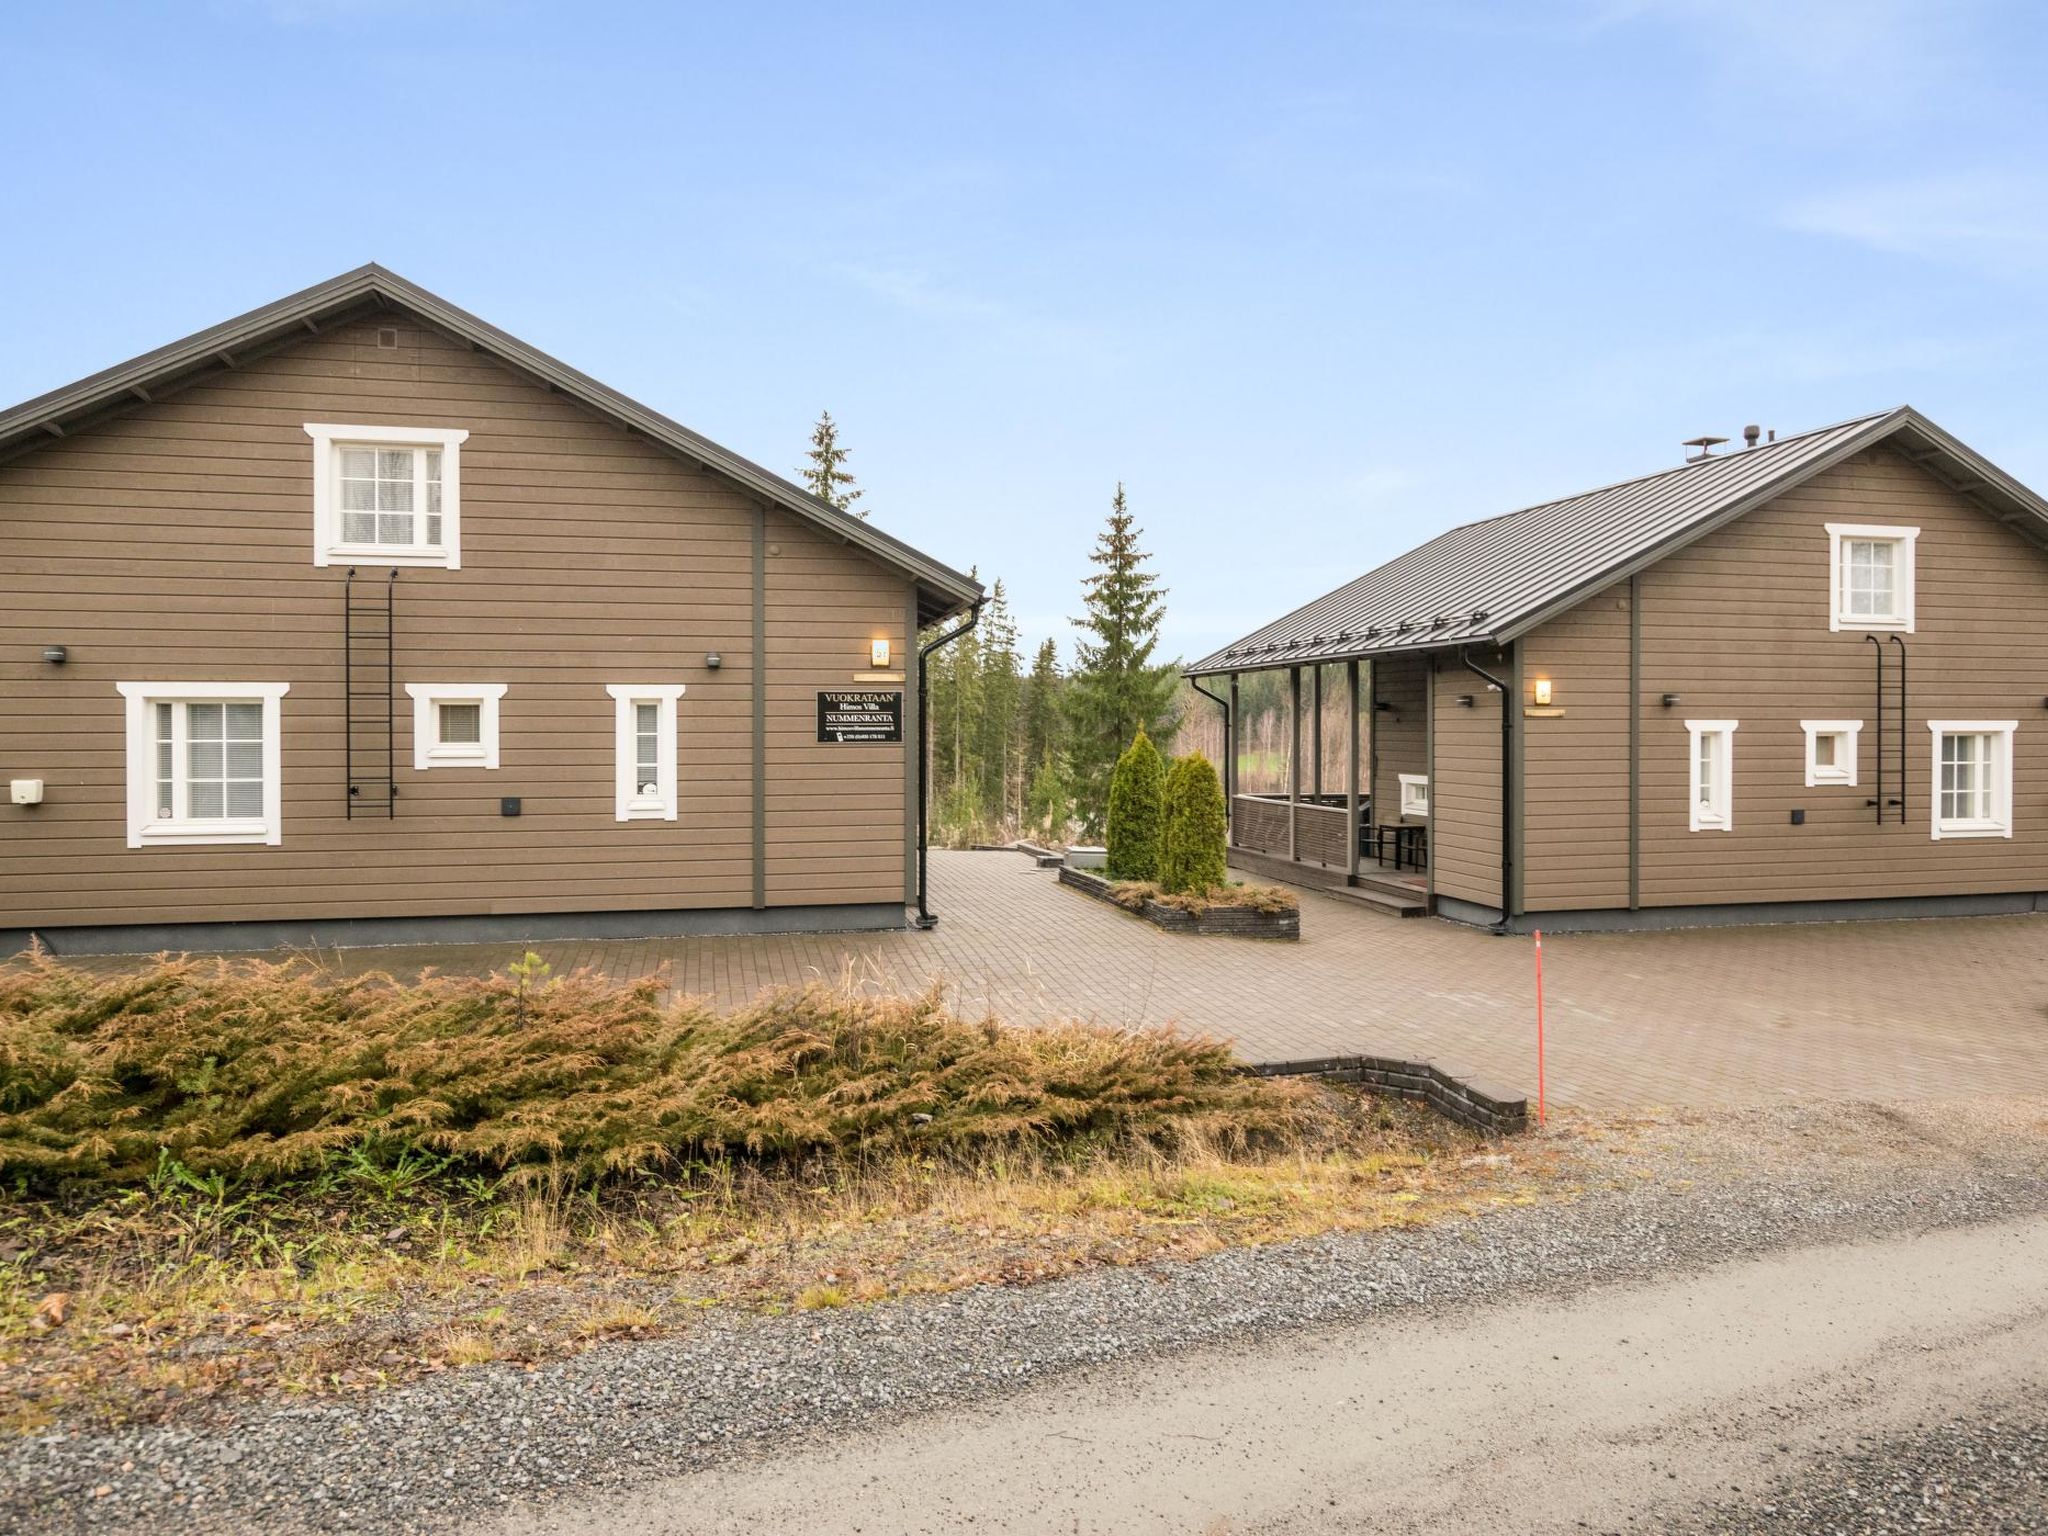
1063, 483, 1176, 834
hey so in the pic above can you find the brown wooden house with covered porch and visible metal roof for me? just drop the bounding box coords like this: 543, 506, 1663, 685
1188, 408, 2048, 930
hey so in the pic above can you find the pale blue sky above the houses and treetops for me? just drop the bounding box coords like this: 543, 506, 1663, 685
0, 0, 2048, 655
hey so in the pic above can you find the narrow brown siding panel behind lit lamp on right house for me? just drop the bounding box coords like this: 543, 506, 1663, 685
1522, 582, 1630, 911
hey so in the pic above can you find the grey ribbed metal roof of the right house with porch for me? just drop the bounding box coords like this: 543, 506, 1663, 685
1186, 406, 2048, 676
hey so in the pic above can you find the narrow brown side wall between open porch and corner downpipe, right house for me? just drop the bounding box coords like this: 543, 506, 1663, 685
1425, 653, 1509, 907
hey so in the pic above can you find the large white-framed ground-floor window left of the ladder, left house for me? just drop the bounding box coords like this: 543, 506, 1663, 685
115, 682, 291, 848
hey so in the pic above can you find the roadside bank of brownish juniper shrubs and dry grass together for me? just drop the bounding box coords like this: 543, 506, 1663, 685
0, 961, 1546, 1432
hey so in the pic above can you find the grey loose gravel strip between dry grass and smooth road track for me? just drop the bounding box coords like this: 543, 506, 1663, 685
0, 1100, 2048, 1536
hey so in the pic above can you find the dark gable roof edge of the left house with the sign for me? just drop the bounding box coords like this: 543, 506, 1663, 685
0, 262, 983, 623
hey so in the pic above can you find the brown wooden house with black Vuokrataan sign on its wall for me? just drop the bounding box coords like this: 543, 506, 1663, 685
0, 266, 981, 952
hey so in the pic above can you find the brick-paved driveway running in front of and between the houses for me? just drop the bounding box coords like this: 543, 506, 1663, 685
284, 852, 2048, 1110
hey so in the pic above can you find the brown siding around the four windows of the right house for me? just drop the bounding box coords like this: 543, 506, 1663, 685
1630, 449, 2048, 907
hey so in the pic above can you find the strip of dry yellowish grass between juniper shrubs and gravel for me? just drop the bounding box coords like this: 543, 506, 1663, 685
0, 1090, 1556, 1430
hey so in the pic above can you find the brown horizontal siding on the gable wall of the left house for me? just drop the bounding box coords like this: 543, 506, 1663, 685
0, 315, 907, 928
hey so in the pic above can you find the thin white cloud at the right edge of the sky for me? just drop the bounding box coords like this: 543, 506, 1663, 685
1784, 170, 2048, 276
